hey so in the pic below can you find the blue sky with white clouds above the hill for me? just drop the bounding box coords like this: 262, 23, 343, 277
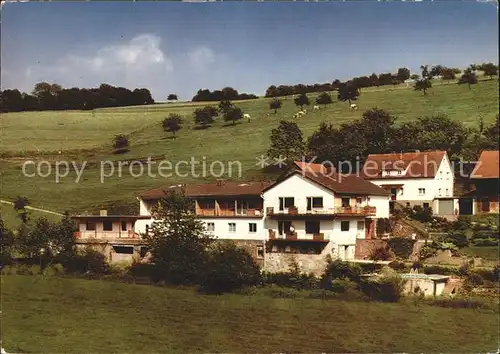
1, 1, 498, 101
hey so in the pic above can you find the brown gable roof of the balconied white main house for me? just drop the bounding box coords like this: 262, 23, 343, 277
263, 170, 390, 196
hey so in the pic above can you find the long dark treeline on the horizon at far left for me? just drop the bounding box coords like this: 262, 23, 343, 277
0, 82, 154, 112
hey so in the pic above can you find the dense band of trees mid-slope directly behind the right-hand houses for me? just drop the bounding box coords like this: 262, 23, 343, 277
268, 108, 499, 170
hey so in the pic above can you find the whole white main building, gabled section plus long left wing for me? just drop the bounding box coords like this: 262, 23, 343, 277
137, 168, 389, 273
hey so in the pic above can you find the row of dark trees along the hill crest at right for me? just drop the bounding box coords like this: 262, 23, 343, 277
265, 63, 498, 97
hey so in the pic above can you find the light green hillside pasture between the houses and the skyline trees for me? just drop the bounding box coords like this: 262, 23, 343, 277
0, 80, 498, 212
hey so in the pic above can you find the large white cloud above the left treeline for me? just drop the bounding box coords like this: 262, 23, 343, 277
25, 34, 173, 92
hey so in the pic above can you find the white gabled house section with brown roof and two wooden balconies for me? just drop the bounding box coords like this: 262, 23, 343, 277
262, 170, 389, 261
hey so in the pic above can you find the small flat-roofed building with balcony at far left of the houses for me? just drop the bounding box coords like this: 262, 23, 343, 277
73, 210, 148, 262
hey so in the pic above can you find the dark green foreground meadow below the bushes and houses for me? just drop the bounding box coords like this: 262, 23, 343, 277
2, 276, 498, 353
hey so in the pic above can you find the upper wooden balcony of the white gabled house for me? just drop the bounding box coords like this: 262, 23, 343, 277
266, 206, 377, 218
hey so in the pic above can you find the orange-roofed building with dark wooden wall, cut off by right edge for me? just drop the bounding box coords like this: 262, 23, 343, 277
470, 150, 500, 214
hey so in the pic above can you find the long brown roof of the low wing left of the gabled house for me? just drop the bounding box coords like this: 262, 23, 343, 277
139, 181, 271, 199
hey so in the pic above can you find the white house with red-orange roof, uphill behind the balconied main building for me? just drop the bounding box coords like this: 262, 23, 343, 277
361, 151, 458, 216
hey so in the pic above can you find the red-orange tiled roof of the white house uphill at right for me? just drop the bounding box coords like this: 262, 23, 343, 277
360, 151, 447, 179
